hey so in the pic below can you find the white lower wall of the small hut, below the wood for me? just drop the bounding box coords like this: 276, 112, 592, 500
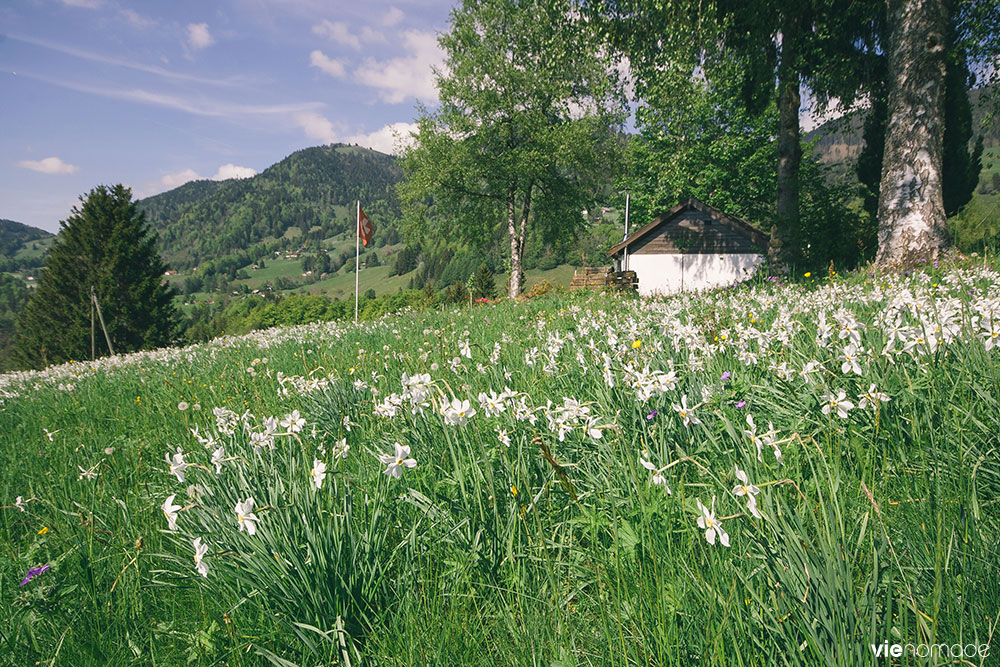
628, 253, 764, 296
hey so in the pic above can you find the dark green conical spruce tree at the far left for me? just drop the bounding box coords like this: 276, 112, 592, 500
15, 185, 178, 367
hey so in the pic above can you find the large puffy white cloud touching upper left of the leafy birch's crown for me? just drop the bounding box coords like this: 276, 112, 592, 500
356, 30, 444, 104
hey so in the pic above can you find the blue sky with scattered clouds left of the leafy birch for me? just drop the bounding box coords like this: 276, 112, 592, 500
0, 0, 454, 231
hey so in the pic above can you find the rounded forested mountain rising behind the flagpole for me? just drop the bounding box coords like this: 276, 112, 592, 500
139, 144, 402, 269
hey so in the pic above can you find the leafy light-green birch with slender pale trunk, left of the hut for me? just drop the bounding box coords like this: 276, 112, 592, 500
399, 0, 623, 298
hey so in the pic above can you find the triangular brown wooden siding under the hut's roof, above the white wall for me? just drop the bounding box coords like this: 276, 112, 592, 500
629, 209, 764, 255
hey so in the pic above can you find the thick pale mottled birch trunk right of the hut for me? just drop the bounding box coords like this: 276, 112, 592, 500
875, 0, 948, 267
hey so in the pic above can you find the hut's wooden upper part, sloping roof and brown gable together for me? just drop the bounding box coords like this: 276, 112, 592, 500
608, 197, 768, 256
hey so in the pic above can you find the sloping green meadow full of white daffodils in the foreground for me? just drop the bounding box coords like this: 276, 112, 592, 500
0, 260, 1000, 666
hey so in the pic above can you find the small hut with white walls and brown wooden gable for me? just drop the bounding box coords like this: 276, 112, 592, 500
608, 197, 768, 295
